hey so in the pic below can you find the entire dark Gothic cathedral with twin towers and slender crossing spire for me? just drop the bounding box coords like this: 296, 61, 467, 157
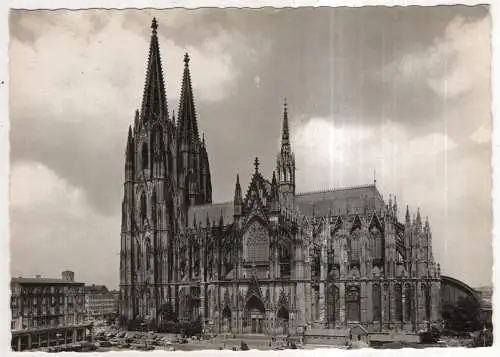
120, 19, 441, 336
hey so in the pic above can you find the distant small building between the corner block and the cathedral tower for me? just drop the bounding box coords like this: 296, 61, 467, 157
84, 285, 118, 321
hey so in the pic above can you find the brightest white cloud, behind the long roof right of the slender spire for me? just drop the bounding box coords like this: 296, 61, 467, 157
292, 118, 492, 283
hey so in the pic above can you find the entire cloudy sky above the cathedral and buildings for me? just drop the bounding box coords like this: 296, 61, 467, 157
10, 6, 492, 287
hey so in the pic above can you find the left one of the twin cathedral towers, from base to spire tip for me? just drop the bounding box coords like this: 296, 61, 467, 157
120, 19, 175, 326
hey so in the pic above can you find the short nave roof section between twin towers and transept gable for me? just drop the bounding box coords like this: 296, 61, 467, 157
188, 201, 234, 228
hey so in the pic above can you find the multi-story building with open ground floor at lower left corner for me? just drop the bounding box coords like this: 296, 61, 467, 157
10, 271, 90, 351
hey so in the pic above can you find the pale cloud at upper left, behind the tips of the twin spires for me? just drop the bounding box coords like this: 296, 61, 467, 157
10, 12, 236, 125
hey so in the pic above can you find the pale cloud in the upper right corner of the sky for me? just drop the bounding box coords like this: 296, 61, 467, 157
382, 17, 491, 143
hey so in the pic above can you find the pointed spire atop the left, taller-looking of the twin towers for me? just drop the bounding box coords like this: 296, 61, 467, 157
141, 18, 168, 121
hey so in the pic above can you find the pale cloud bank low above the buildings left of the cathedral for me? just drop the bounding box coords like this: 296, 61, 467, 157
10, 162, 120, 287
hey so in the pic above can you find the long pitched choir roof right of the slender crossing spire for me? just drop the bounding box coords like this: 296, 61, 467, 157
295, 185, 384, 217
